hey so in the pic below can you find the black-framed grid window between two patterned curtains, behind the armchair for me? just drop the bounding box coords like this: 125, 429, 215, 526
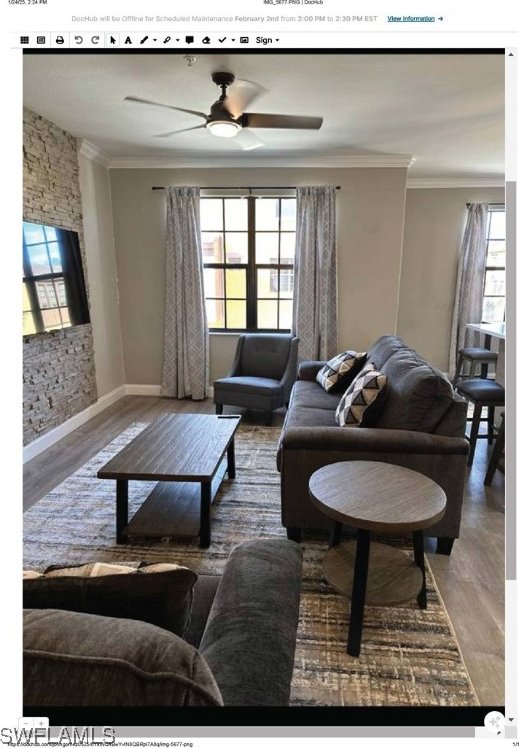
200, 195, 296, 331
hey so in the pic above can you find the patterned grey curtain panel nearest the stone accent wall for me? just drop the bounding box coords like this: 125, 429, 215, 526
161, 187, 209, 400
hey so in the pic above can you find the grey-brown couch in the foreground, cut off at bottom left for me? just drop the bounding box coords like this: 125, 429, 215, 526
24, 539, 302, 708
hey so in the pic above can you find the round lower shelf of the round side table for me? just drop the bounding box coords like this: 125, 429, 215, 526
323, 541, 423, 606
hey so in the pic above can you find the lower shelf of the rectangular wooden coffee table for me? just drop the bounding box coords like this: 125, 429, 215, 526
120, 459, 227, 547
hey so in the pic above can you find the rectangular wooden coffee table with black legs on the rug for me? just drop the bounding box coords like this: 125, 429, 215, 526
97, 413, 240, 548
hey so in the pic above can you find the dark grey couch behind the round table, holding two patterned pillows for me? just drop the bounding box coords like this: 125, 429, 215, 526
277, 335, 468, 554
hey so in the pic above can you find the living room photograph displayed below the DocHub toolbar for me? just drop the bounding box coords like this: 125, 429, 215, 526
22, 49, 506, 724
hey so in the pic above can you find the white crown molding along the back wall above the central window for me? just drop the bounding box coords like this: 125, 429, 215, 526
109, 154, 414, 169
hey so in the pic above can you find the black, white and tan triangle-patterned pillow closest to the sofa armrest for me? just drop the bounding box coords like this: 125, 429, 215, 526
335, 364, 387, 427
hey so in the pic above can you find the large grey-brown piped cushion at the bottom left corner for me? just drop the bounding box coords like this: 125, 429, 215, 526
23, 608, 223, 707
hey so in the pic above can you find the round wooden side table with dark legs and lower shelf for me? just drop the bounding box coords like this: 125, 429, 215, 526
309, 460, 447, 657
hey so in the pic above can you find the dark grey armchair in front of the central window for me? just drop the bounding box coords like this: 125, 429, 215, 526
214, 333, 299, 426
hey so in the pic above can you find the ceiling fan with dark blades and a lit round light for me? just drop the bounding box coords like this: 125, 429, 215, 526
125, 72, 323, 150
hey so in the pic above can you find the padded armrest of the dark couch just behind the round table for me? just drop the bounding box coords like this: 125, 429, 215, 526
281, 426, 469, 459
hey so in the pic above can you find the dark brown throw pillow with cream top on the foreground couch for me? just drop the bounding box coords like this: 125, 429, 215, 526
23, 563, 197, 636
